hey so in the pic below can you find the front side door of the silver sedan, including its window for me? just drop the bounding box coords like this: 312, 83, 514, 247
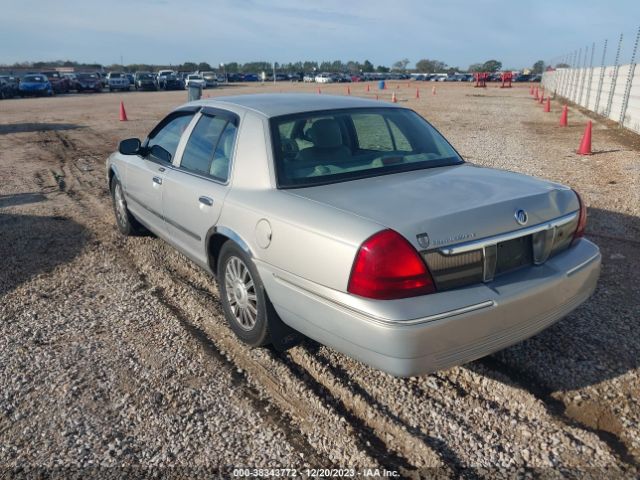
125, 112, 194, 237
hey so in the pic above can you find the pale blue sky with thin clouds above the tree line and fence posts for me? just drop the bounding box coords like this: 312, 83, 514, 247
0, 0, 640, 69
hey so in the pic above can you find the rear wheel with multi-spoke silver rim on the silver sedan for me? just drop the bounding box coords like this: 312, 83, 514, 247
218, 240, 276, 347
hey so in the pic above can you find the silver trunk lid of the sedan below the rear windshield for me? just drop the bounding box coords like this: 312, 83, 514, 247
288, 164, 579, 250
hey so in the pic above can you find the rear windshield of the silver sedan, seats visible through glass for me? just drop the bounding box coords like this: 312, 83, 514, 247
271, 108, 463, 188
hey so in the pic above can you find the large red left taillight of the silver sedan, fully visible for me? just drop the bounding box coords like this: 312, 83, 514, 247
347, 230, 435, 300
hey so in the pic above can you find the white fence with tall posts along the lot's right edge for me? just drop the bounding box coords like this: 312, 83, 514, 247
542, 28, 640, 133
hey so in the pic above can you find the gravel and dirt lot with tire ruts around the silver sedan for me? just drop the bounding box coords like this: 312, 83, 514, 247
0, 82, 640, 478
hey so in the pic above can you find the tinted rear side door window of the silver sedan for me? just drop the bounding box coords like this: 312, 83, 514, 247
180, 115, 237, 182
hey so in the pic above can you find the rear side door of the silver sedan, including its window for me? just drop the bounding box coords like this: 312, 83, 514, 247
162, 108, 239, 265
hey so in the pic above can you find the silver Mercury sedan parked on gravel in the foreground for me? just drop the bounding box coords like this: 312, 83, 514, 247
106, 94, 600, 376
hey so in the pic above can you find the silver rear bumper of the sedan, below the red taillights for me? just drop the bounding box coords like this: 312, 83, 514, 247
257, 239, 601, 376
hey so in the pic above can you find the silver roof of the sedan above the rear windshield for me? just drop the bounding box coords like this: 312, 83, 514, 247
184, 93, 402, 118
